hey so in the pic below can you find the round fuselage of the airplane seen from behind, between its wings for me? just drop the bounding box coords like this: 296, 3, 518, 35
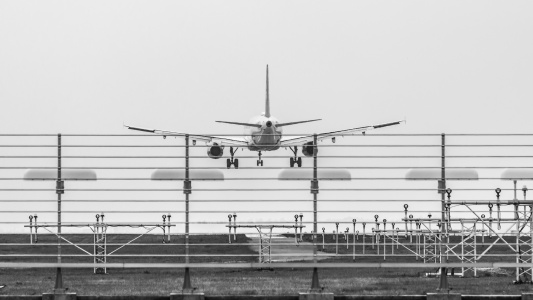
244, 115, 283, 151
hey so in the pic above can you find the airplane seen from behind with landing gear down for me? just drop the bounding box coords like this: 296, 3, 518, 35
124, 65, 403, 169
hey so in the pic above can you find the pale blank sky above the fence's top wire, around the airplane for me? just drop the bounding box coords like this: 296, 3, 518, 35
0, 1, 533, 236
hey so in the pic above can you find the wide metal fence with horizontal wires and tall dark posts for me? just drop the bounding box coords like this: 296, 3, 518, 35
0, 134, 533, 290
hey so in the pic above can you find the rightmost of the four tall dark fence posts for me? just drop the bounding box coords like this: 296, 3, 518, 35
437, 133, 450, 291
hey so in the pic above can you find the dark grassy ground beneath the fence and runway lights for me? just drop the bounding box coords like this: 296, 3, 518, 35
0, 235, 532, 295
